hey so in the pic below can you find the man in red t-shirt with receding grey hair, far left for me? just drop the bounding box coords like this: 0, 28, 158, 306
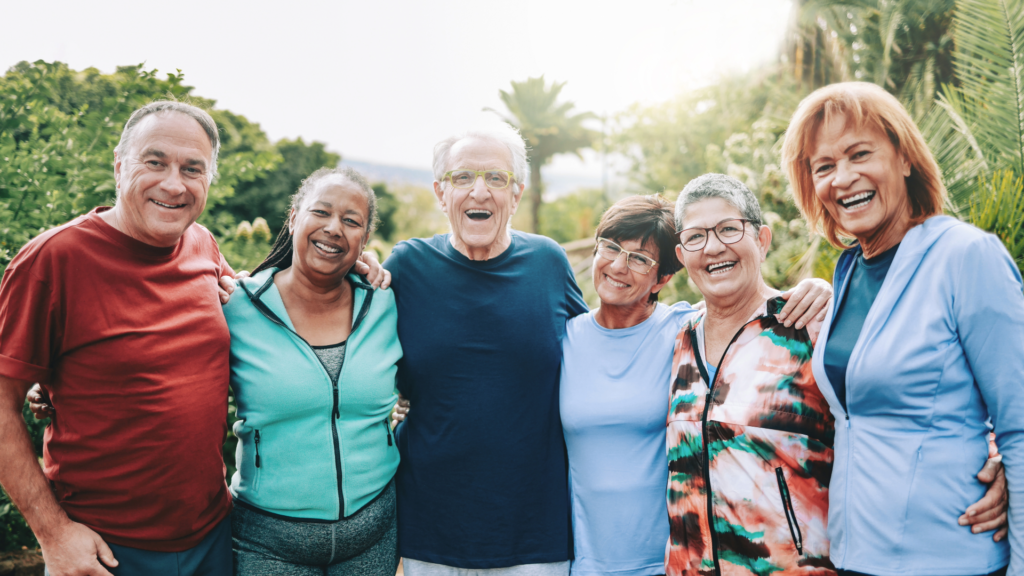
0, 102, 233, 576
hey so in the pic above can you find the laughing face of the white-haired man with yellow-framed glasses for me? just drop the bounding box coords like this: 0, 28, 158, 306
434, 137, 524, 260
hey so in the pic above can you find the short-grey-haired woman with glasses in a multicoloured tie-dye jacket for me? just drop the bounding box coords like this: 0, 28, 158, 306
666, 174, 835, 576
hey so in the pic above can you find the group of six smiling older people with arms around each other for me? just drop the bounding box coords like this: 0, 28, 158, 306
0, 83, 1024, 576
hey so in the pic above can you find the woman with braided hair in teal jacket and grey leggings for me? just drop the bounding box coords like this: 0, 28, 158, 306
224, 168, 401, 576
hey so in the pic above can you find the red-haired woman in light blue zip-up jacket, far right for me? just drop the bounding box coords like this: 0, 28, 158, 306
783, 83, 1024, 576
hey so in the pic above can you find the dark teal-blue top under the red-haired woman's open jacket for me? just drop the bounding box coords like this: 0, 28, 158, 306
824, 244, 899, 410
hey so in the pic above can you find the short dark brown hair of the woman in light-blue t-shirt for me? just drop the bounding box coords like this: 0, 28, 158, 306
594, 194, 683, 302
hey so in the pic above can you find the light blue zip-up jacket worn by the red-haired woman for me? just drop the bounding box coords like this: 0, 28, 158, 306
813, 216, 1024, 576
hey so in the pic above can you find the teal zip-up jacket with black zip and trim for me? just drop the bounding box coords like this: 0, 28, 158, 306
224, 269, 401, 521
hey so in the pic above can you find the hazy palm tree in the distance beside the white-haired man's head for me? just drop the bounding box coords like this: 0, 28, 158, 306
484, 76, 598, 233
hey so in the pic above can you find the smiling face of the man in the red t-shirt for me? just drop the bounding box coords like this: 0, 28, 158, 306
114, 112, 213, 247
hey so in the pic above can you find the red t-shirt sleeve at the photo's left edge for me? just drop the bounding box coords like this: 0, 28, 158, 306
0, 244, 59, 383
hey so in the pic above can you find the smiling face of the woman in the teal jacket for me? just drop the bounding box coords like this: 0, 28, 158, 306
288, 177, 370, 283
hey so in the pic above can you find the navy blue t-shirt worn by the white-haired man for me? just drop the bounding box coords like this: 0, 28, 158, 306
384, 232, 588, 568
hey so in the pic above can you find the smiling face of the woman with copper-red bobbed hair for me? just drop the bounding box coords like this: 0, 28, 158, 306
810, 118, 910, 253
